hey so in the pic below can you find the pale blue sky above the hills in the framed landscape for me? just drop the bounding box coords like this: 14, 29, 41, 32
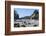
15, 8, 38, 18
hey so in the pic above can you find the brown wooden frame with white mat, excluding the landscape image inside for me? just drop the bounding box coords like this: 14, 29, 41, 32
5, 1, 45, 35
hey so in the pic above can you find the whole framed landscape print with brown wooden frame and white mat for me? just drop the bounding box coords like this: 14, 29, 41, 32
5, 1, 45, 35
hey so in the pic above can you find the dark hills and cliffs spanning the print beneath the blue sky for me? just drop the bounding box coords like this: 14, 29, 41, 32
14, 10, 39, 20
